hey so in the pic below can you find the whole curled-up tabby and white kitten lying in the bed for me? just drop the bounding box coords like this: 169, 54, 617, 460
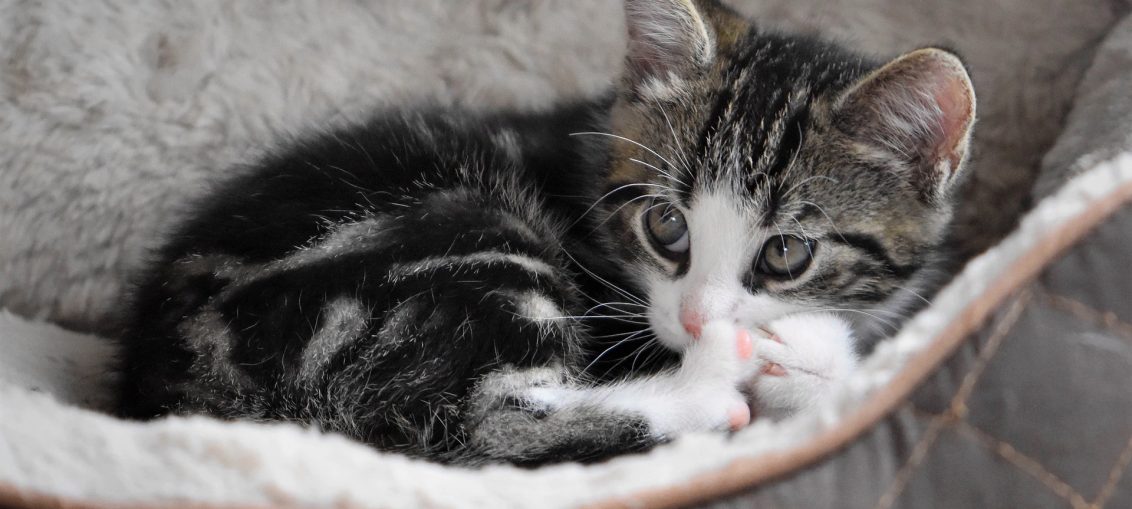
114, 0, 975, 465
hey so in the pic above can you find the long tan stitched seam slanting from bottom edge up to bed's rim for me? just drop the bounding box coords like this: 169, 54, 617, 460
875, 287, 1032, 509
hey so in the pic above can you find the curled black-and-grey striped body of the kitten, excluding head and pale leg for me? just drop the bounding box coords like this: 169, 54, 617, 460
123, 105, 661, 460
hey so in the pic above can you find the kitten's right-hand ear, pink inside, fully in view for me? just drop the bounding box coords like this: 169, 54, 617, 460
835, 49, 975, 201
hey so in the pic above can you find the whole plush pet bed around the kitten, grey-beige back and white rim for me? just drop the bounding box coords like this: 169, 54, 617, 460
0, 0, 1132, 508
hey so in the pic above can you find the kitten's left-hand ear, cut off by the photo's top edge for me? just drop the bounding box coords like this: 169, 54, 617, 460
625, 0, 715, 98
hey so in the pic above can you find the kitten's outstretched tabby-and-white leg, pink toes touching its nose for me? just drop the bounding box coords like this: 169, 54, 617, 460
465, 321, 784, 465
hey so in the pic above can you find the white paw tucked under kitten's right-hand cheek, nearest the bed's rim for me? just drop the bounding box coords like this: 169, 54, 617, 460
748, 313, 857, 419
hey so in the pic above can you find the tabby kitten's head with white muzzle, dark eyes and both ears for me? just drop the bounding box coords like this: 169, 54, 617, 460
601, 0, 975, 348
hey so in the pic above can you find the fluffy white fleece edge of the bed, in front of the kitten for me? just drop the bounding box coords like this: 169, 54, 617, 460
0, 154, 1132, 508
